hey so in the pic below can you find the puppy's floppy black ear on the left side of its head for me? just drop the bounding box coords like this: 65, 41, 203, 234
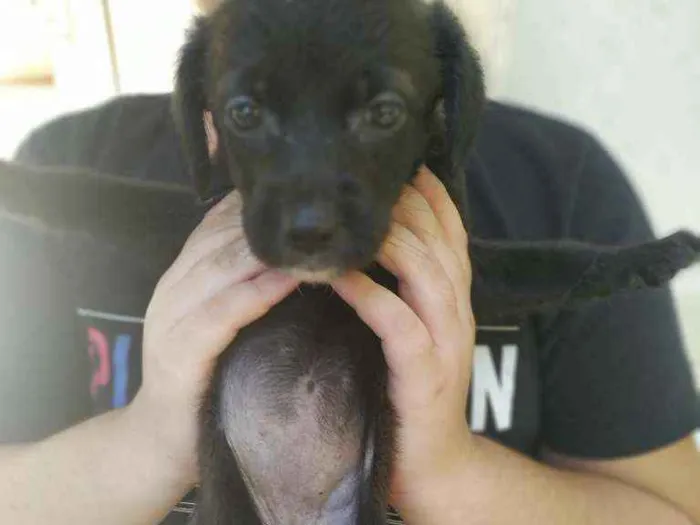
172, 18, 220, 202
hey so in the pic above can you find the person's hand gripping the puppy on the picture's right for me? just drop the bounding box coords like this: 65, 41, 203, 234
332, 169, 475, 523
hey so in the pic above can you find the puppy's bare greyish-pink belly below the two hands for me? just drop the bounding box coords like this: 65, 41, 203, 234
220, 334, 362, 525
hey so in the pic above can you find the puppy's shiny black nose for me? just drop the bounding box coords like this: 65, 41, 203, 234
286, 205, 336, 254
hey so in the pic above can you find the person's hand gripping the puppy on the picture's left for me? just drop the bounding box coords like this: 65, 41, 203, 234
130, 188, 298, 483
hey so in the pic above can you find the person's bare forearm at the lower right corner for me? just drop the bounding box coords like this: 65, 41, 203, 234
404, 436, 692, 525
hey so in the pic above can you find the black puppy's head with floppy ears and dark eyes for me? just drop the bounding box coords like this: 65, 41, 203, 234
174, 0, 483, 281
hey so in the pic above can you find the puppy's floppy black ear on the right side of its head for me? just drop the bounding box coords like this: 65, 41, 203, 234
431, 0, 486, 203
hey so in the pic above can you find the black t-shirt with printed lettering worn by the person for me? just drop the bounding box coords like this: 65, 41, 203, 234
0, 95, 700, 523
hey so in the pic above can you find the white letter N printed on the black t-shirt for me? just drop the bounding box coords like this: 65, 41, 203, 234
470, 345, 518, 432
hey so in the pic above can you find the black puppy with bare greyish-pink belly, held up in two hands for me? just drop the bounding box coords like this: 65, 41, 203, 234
174, 0, 698, 525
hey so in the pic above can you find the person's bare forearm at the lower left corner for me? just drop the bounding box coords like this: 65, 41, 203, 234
0, 408, 188, 525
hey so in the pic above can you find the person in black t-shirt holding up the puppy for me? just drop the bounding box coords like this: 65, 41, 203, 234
0, 1, 700, 525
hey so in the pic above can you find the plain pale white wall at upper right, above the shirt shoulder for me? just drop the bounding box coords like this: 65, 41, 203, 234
497, 0, 700, 239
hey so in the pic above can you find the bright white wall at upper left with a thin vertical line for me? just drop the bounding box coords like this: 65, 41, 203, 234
0, 0, 193, 158
